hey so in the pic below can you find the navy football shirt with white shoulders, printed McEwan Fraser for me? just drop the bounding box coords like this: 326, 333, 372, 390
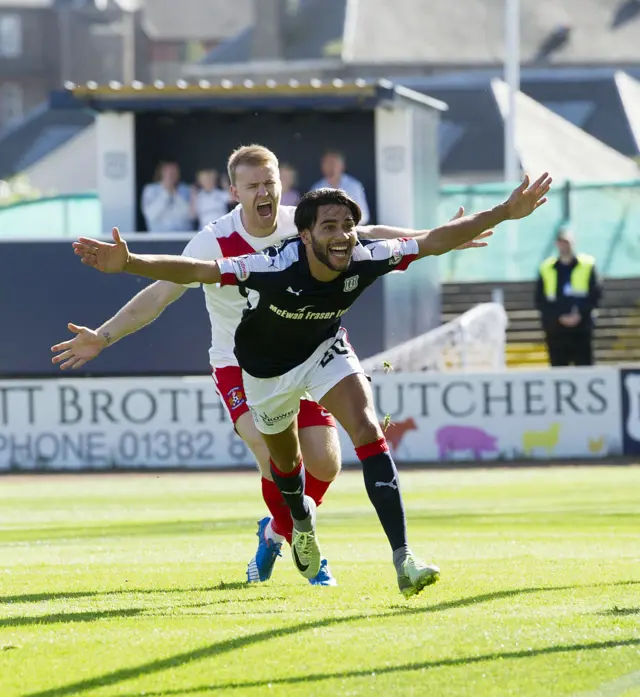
218, 237, 418, 378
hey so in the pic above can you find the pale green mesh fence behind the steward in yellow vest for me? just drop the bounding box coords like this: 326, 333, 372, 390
438, 181, 640, 282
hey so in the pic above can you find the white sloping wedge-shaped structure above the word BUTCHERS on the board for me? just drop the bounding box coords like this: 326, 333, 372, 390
362, 303, 508, 373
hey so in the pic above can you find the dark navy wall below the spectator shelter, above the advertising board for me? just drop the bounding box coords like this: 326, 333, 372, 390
0, 241, 383, 377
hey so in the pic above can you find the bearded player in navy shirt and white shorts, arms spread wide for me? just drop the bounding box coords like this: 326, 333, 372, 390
74, 173, 551, 597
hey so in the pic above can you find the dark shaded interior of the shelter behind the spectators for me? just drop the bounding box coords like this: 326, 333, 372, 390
136, 111, 376, 230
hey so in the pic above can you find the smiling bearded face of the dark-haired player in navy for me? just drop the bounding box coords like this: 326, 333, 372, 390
310, 205, 358, 272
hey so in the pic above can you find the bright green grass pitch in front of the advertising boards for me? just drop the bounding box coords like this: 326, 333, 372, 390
0, 467, 640, 697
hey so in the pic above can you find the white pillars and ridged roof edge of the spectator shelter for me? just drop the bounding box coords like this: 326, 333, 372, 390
90, 80, 447, 347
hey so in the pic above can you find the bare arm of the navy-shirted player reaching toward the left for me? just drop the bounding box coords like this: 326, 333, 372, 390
73, 228, 221, 285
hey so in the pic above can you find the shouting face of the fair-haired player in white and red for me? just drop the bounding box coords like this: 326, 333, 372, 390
231, 163, 282, 230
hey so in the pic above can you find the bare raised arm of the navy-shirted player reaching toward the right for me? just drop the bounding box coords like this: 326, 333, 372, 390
415, 172, 551, 258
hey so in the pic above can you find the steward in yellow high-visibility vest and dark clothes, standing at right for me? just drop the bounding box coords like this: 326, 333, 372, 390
535, 227, 602, 367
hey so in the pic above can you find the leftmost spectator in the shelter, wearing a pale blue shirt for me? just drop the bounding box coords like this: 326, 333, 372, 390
142, 162, 193, 232
